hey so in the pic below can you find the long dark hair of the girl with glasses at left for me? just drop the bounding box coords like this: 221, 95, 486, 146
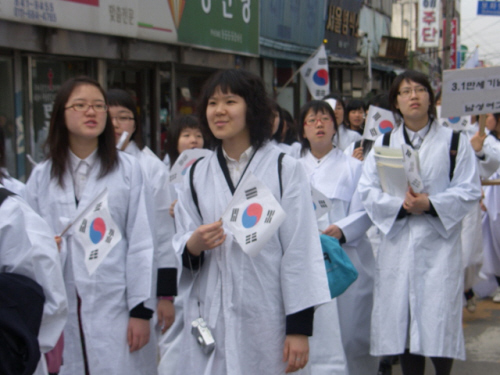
45, 76, 118, 187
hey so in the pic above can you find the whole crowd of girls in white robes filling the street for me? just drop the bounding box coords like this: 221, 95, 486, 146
0, 69, 500, 375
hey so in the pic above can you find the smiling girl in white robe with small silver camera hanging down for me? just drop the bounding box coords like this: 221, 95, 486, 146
174, 69, 330, 375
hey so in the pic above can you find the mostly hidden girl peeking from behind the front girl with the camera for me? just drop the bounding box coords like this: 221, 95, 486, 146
158, 115, 205, 375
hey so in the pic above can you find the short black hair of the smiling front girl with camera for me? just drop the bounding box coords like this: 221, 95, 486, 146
198, 69, 273, 149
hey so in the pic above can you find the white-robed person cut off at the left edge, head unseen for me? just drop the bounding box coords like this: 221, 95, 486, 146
0, 184, 68, 375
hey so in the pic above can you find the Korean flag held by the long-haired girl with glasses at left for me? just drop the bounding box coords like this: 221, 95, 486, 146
75, 189, 122, 275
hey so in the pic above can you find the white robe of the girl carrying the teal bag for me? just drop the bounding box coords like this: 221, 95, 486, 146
300, 148, 378, 375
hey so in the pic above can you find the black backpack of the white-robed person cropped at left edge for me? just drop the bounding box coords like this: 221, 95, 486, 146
0, 188, 45, 375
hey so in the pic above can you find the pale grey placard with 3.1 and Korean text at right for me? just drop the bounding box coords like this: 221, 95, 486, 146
441, 66, 500, 117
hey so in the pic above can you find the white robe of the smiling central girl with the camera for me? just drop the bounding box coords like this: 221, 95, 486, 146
174, 143, 330, 375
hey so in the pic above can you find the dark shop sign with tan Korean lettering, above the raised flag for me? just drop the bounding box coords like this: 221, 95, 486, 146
325, 0, 362, 57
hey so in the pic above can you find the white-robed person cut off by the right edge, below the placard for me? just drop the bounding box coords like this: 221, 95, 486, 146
481, 113, 500, 303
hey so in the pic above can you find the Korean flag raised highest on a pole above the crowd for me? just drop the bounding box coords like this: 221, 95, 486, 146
300, 44, 330, 100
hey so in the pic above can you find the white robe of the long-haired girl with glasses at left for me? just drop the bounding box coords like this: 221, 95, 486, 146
26, 152, 156, 375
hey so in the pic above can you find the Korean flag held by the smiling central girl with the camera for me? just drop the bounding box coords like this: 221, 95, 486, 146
222, 171, 286, 257
